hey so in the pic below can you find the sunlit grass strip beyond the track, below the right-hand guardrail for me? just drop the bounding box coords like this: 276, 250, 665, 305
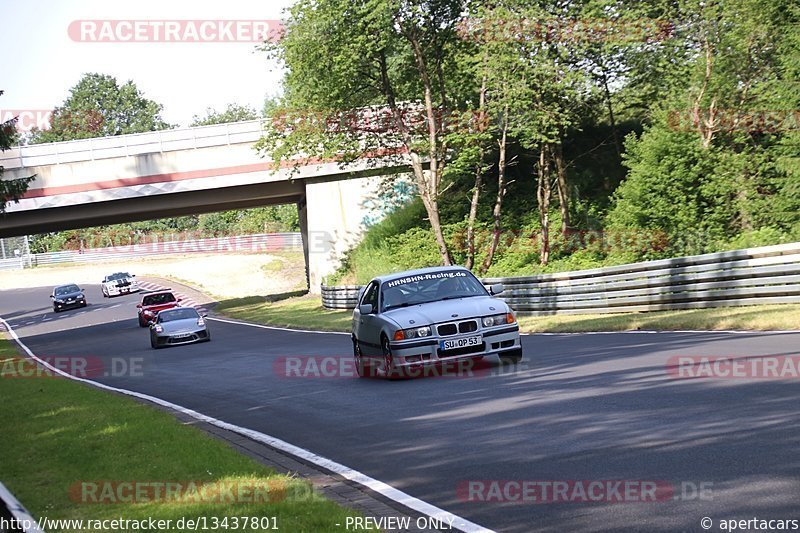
217, 294, 800, 333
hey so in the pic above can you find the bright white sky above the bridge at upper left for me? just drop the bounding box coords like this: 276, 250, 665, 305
0, 0, 293, 126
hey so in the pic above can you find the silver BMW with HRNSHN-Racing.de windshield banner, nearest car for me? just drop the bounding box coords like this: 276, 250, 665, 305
352, 267, 522, 378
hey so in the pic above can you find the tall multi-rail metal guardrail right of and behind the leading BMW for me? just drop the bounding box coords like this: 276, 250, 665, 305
322, 243, 800, 315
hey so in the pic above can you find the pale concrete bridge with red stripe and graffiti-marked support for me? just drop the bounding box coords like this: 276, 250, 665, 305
0, 120, 409, 291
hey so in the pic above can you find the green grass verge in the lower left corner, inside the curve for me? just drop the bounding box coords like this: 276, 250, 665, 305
0, 339, 370, 532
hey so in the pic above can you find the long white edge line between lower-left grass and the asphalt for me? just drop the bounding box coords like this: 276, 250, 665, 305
0, 318, 495, 533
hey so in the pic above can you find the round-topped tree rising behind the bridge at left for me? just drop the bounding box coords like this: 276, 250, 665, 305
30, 74, 171, 144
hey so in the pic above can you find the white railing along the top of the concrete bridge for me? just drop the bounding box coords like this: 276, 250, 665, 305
0, 119, 263, 169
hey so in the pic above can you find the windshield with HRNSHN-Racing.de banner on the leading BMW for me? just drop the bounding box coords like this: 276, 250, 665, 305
381, 270, 489, 311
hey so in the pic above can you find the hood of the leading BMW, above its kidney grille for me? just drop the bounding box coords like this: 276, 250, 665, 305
383, 296, 508, 329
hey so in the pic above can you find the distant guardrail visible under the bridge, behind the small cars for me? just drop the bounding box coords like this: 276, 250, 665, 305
0, 233, 303, 270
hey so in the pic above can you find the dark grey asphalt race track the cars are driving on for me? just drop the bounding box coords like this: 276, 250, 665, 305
0, 286, 800, 532
